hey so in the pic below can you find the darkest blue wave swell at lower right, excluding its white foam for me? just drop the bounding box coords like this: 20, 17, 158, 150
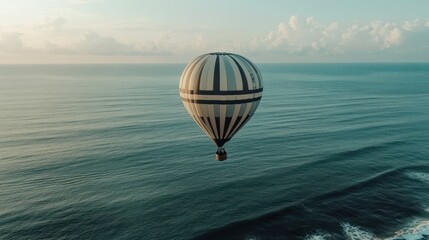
195, 166, 429, 239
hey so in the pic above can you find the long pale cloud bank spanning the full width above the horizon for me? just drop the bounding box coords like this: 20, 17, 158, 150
0, 14, 429, 62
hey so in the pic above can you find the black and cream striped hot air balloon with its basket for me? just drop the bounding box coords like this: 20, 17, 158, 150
179, 52, 263, 161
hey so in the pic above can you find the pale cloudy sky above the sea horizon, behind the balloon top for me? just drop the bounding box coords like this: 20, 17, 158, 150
0, 0, 429, 64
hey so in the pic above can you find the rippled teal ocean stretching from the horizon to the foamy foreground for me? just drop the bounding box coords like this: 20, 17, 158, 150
0, 63, 429, 240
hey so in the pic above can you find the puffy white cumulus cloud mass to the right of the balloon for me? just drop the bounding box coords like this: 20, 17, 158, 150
248, 16, 429, 55
